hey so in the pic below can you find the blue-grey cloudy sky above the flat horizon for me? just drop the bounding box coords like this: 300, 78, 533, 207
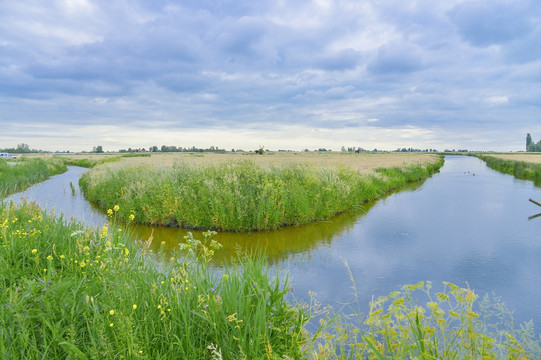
0, 0, 541, 151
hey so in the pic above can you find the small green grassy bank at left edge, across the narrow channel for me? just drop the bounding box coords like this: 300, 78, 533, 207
0, 158, 67, 199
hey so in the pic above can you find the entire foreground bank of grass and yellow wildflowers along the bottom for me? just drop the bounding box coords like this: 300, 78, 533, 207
0, 204, 539, 360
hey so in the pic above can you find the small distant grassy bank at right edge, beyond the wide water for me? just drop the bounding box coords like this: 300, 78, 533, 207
476, 155, 541, 186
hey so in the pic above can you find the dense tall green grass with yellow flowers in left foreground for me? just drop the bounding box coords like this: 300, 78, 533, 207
0, 204, 308, 359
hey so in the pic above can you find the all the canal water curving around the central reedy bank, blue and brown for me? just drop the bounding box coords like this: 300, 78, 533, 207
3, 156, 541, 326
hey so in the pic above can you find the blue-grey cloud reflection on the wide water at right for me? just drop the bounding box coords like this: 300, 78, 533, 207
286, 157, 541, 323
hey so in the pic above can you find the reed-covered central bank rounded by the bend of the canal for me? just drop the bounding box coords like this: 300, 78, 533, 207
80, 158, 443, 231
